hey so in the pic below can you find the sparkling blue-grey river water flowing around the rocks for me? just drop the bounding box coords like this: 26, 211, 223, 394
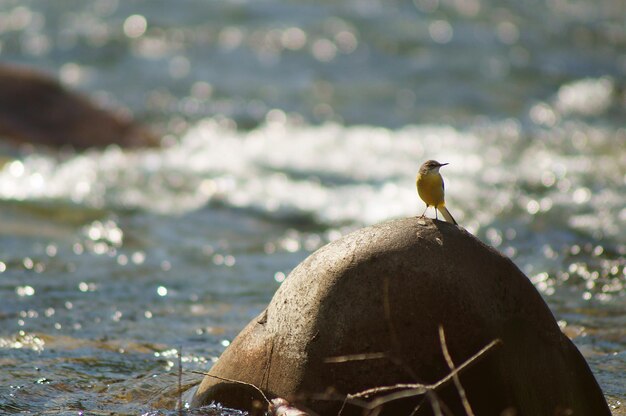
0, 0, 626, 415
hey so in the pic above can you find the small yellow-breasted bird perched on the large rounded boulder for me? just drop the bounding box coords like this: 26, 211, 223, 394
415, 160, 457, 225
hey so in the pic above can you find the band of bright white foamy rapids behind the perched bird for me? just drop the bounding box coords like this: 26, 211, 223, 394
0, 80, 626, 242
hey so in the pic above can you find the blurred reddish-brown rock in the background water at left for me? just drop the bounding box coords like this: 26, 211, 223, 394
0, 65, 158, 149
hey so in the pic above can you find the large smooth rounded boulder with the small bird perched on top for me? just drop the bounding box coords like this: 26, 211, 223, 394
192, 218, 610, 416
